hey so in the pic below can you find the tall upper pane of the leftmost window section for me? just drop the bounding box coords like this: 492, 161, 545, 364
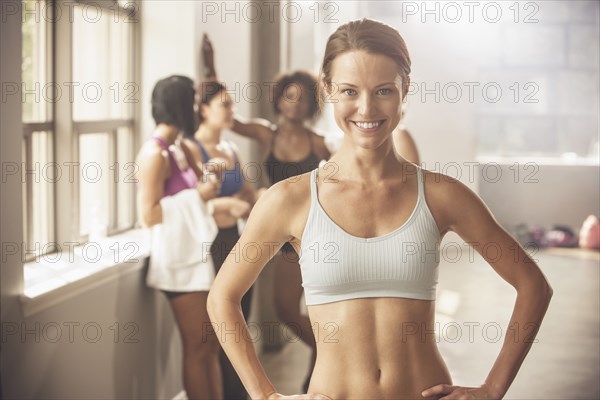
20, 0, 50, 122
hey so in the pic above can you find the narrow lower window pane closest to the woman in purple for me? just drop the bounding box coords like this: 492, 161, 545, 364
117, 127, 137, 229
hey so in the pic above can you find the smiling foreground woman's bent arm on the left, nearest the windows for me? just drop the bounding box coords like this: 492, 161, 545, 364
208, 181, 291, 399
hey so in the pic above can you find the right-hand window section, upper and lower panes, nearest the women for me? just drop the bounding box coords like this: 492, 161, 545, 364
73, 5, 138, 237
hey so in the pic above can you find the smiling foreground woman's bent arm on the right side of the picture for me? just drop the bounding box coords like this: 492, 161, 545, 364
423, 177, 552, 399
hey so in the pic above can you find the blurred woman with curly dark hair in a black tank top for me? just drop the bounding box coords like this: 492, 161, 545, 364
203, 34, 330, 387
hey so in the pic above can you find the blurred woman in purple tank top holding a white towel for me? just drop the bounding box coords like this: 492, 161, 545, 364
136, 76, 248, 399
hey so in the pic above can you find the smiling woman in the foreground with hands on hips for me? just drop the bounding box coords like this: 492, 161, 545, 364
208, 19, 552, 399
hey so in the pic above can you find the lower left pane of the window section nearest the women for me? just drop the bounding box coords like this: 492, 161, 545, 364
79, 132, 114, 236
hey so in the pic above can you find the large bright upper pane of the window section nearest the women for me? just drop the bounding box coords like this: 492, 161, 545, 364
73, 7, 138, 121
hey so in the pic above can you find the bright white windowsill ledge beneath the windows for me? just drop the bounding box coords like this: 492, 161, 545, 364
21, 229, 150, 316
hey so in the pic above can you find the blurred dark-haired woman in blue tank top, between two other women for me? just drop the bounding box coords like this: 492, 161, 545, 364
185, 82, 257, 400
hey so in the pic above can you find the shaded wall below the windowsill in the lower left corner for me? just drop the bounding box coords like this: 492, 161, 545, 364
2, 265, 181, 399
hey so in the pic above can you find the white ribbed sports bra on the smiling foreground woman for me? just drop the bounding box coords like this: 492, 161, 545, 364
300, 167, 440, 305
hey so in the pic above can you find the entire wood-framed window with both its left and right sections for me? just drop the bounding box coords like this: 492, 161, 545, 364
22, 0, 138, 260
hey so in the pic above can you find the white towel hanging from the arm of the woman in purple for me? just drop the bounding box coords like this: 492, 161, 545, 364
146, 189, 218, 292
